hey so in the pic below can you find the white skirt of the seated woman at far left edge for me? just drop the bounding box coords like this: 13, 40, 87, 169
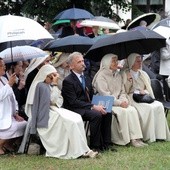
0, 118, 27, 139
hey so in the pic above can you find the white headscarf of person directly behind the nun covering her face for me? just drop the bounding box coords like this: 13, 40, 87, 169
24, 54, 49, 80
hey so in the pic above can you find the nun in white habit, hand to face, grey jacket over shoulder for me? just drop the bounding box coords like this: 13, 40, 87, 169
26, 64, 98, 159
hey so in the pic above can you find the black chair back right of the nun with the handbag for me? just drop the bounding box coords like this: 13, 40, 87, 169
151, 79, 165, 101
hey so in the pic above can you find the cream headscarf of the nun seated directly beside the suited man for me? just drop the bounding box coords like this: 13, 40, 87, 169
92, 53, 118, 84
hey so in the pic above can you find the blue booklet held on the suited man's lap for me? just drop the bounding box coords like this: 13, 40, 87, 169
91, 95, 114, 113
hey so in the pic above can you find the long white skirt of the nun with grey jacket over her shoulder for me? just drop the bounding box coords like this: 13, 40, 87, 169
37, 106, 90, 159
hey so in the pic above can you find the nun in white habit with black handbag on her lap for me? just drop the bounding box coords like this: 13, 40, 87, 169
123, 53, 170, 142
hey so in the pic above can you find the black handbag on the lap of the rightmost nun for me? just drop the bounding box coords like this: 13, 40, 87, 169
133, 93, 154, 103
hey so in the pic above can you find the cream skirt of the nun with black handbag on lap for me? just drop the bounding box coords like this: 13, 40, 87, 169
131, 96, 170, 142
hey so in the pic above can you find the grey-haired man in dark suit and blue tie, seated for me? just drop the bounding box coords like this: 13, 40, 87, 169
62, 52, 112, 150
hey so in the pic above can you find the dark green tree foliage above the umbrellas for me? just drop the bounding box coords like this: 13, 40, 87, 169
0, 0, 131, 22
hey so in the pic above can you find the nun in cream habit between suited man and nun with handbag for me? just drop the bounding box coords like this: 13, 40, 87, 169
92, 54, 146, 147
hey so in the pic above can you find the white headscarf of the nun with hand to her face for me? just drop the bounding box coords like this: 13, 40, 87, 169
25, 64, 56, 117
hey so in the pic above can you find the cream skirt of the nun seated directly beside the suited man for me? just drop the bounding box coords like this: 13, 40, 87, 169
111, 106, 143, 145
